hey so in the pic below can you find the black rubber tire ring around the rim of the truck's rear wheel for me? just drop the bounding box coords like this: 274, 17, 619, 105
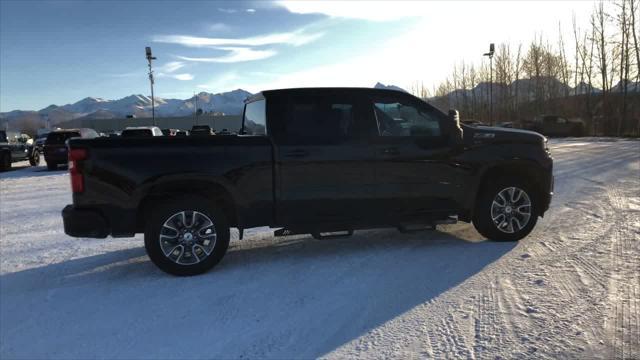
144, 195, 229, 276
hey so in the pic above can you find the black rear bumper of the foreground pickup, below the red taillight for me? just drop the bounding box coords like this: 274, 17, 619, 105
62, 205, 110, 239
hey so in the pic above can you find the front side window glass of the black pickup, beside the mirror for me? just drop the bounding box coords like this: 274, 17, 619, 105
373, 98, 441, 137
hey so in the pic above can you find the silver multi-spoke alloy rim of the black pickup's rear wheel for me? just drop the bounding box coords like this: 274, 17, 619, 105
160, 211, 216, 265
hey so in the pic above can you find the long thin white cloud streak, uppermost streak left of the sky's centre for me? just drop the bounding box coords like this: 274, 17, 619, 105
153, 31, 324, 48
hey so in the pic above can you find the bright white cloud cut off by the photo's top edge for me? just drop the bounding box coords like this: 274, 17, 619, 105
276, 0, 428, 21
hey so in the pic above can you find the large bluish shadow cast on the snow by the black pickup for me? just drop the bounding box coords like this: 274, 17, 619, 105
0, 230, 515, 358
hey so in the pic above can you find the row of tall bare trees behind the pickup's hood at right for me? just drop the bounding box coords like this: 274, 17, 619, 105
410, 0, 640, 136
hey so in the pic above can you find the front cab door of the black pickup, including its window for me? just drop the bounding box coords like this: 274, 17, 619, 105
369, 93, 460, 221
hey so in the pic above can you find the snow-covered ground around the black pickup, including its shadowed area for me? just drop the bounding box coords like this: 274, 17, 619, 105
0, 139, 640, 359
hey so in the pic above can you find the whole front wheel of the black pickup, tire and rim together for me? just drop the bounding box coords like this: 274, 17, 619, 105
473, 178, 538, 241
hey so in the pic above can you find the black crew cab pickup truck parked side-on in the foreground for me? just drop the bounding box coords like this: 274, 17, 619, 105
62, 88, 553, 275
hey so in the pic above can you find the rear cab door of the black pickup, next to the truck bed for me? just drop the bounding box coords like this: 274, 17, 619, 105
267, 93, 376, 228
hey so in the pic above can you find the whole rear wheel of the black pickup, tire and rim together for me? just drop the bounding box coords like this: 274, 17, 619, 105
144, 196, 229, 276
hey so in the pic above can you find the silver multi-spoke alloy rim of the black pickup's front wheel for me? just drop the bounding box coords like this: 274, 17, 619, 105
491, 187, 531, 234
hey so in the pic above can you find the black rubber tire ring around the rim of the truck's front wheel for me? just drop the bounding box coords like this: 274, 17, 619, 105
473, 177, 539, 241
